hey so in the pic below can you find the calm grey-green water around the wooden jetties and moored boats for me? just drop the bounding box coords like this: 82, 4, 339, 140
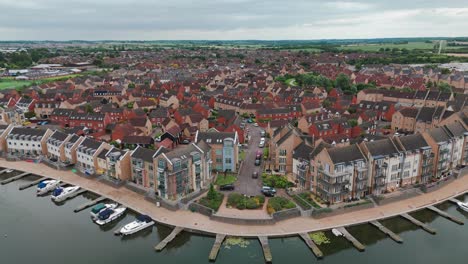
0, 172, 468, 264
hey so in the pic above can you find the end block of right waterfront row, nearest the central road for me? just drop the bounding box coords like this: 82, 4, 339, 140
314, 145, 369, 203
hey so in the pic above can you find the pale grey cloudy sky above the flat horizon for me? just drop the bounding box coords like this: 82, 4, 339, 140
0, 0, 468, 40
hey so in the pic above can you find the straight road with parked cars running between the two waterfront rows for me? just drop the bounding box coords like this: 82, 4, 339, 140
235, 124, 264, 196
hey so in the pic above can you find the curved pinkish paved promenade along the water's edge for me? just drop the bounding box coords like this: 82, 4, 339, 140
0, 160, 468, 237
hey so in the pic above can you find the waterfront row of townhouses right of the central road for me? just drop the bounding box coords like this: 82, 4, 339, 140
308, 122, 468, 203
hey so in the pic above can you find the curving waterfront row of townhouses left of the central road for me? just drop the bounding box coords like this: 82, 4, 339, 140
0, 125, 214, 200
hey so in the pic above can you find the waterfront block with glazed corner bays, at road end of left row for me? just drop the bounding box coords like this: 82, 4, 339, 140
155, 143, 212, 200
